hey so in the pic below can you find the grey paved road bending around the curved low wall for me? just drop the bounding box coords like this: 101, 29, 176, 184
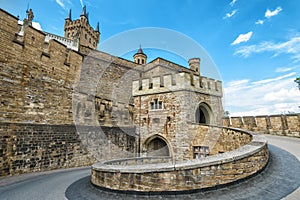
0, 135, 300, 200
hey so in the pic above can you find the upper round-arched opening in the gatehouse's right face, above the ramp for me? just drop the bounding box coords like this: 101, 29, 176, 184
195, 102, 213, 124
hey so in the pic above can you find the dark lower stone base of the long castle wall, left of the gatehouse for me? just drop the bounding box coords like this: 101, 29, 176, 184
0, 123, 135, 176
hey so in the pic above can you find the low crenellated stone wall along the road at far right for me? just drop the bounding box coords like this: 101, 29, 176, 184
223, 113, 300, 137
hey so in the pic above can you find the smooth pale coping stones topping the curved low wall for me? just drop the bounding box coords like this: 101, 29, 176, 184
92, 126, 267, 173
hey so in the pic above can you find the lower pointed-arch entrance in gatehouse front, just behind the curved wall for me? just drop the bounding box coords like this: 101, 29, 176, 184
146, 137, 170, 156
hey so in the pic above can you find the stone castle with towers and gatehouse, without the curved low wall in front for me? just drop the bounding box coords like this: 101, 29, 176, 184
0, 7, 223, 174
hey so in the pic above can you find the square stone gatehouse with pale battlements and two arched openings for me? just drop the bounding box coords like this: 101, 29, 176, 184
132, 47, 223, 160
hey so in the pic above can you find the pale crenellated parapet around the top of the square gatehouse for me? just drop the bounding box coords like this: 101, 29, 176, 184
132, 72, 222, 96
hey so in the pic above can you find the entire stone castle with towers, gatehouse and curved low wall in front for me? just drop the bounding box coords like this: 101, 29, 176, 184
0, 7, 274, 192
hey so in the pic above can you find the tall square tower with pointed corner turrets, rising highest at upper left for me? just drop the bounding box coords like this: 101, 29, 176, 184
64, 6, 100, 49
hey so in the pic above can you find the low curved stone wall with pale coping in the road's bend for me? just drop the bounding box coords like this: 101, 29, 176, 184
91, 128, 269, 192
